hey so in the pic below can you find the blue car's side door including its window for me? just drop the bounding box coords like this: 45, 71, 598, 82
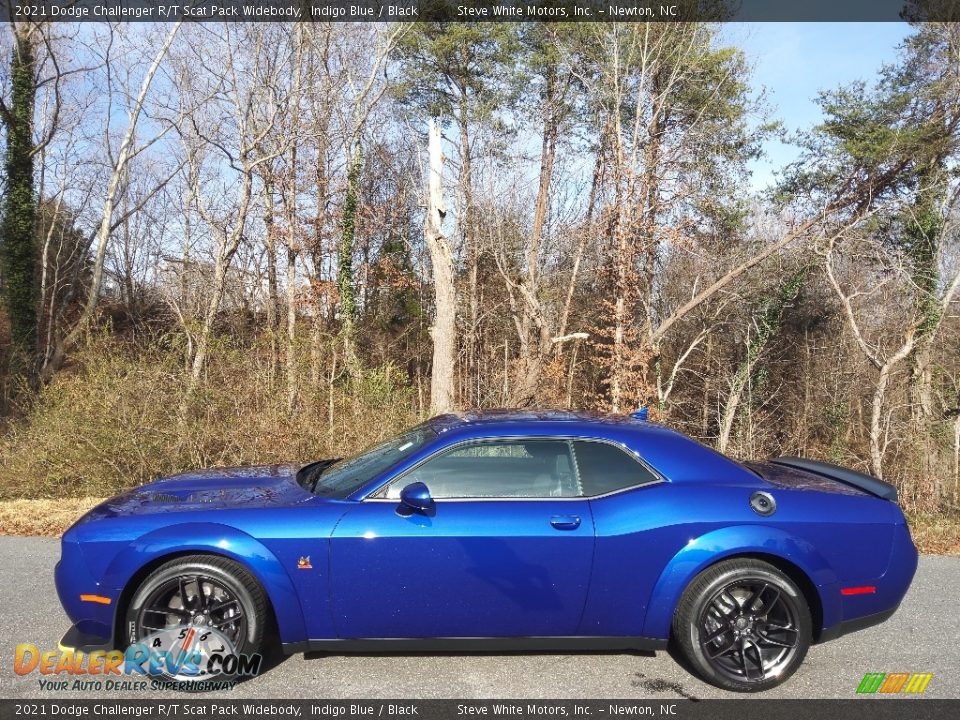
330, 439, 594, 638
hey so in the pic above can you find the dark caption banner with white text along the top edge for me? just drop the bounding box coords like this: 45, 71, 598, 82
0, 0, 960, 22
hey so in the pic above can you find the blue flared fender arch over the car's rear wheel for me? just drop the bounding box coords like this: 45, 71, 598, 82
643, 525, 841, 638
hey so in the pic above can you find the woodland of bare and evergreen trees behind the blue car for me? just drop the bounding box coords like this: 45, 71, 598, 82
0, 16, 960, 552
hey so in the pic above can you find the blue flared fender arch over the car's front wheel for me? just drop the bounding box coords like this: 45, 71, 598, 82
102, 522, 306, 642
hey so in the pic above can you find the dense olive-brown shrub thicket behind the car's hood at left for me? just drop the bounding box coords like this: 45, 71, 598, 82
0, 338, 417, 499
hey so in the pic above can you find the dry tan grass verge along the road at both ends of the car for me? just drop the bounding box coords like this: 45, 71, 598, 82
0, 497, 960, 555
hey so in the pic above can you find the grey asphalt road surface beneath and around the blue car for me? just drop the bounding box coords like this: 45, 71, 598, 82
0, 537, 960, 700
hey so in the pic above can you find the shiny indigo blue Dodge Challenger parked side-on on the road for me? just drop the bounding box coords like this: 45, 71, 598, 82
56, 411, 917, 691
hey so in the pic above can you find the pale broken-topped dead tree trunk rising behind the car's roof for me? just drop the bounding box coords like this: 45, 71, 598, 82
423, 119, 457, 415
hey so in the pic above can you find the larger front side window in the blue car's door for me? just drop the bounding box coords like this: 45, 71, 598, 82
386, 440, 580, 500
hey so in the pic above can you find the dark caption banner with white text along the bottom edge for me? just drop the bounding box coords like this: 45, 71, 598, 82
0, 695, 960, 720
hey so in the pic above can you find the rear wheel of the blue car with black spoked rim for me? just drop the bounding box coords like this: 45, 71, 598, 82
673, 558, 813, 692
